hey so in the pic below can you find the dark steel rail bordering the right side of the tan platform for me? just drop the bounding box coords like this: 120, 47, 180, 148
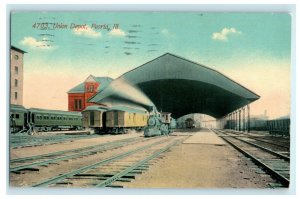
222, 137, 290, 187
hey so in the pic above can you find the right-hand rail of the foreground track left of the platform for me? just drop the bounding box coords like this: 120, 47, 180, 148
96, 140, 180, 187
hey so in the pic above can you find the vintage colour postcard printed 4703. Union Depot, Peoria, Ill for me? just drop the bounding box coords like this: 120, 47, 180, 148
8, 11, 293, 190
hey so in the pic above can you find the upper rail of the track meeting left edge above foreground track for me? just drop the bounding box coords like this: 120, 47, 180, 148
10, 138, 142, 163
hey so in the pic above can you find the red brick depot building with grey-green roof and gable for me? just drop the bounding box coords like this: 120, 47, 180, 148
68, 75, 113, 111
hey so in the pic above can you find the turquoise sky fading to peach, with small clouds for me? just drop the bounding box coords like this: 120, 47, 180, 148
11, 12, 291, 119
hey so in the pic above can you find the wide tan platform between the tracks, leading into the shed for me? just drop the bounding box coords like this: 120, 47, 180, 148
123, 129, 274, 188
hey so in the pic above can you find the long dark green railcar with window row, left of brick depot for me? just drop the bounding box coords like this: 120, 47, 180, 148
28, 108, 82, 131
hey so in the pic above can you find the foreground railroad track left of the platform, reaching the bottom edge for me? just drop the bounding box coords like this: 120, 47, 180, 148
31, 136, 188, 187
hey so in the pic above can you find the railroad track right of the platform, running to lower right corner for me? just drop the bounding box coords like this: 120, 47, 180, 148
214, 130, 290, 187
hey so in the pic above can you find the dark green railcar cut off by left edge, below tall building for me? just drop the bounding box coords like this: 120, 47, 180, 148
9, 104, 28, 133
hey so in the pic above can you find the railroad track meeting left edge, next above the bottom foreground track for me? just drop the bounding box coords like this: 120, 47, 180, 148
10, 137, 144, 173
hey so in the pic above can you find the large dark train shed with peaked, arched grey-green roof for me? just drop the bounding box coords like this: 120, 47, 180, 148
90, 53, 259, 125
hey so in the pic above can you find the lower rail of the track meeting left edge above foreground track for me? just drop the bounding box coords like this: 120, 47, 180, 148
10, 137, 146, 172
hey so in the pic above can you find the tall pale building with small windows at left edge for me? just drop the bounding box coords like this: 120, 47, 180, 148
10, 46, 27, 105
